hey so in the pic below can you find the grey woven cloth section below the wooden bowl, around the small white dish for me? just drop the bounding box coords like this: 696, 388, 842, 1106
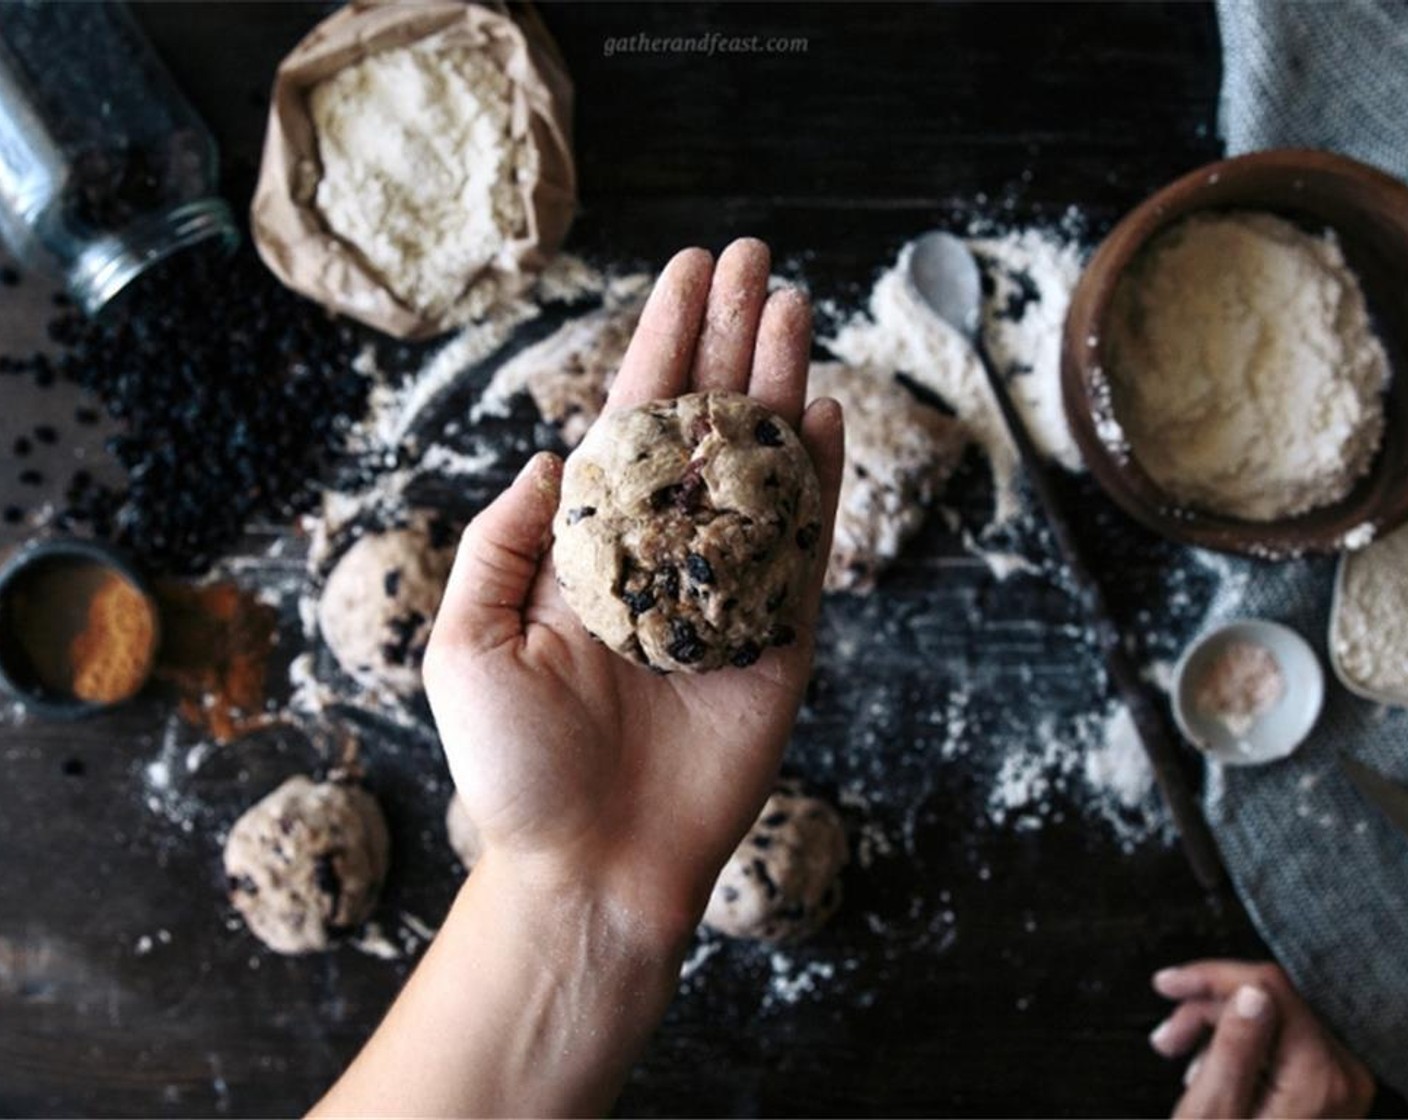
1204, 558, 1408, 1093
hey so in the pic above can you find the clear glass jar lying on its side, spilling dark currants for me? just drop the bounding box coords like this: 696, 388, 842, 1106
0, 0, 239, 314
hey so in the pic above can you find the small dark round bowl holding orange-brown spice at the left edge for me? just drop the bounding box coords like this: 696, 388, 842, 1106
0, 540, 161, 718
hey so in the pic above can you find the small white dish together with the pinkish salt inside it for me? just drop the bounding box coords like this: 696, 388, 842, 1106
1173, 618, 1325, 766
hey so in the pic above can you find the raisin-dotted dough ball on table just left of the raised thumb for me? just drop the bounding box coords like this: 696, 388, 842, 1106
318, 523, 455, 696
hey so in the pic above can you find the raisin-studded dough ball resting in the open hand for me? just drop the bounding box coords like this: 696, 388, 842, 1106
553, 393, 821, 672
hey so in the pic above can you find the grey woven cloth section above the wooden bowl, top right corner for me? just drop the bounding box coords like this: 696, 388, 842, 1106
1218, 0, 1408, 179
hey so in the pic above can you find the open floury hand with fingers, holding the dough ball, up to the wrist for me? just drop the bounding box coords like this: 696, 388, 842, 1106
425, 239, 842, 923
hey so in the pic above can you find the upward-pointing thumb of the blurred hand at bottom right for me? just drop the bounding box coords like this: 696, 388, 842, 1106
1173, 983, 1276, 1117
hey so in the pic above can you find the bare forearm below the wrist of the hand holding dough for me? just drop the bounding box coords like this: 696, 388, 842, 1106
314, 858, 683, 1116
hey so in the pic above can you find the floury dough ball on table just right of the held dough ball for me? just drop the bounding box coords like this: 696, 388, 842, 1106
807, 362, 967, 592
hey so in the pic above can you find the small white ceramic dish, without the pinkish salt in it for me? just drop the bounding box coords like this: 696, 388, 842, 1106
1171, 618, 1325, 766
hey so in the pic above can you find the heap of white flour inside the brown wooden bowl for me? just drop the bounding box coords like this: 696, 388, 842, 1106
1104, 213, 1388, 521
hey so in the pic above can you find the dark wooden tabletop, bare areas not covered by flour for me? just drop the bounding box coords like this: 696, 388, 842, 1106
0, 3, 1396, 1114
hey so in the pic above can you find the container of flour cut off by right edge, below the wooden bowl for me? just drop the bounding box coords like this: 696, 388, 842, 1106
1331, 528, 1408, 699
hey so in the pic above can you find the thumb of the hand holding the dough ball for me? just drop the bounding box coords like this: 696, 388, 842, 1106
427, 451, 562, 657
